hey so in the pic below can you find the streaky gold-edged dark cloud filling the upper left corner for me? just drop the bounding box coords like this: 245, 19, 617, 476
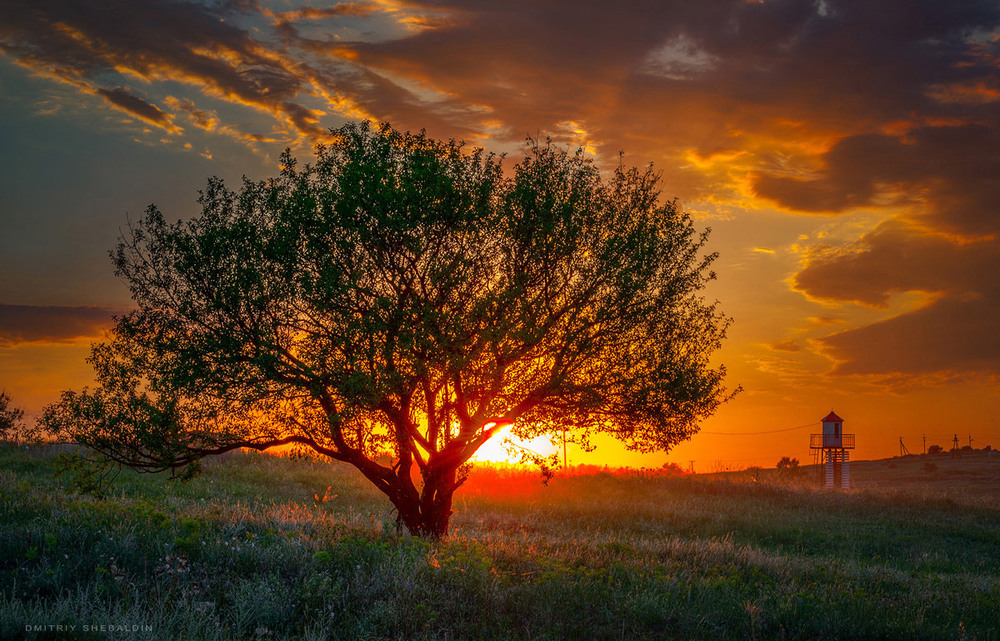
0, 0, 336, 142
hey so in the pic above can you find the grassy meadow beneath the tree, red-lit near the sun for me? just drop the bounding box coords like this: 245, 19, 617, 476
0, 446, 1000, 640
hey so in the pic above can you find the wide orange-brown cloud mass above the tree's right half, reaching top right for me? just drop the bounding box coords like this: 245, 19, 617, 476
320, 0, 1000, 202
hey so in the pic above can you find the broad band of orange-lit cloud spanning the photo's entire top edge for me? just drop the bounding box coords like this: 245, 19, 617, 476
0, 0, 1000, 184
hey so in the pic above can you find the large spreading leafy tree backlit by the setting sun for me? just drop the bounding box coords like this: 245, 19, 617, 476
43, 123, 729, 536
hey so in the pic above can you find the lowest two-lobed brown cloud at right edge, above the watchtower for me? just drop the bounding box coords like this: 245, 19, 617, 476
794, 221, 1000, 374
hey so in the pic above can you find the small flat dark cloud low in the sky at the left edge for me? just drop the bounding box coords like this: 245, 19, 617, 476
0, 304, 113, 345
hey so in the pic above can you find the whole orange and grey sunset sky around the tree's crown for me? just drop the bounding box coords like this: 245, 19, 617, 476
0, 0, 1000, 472
